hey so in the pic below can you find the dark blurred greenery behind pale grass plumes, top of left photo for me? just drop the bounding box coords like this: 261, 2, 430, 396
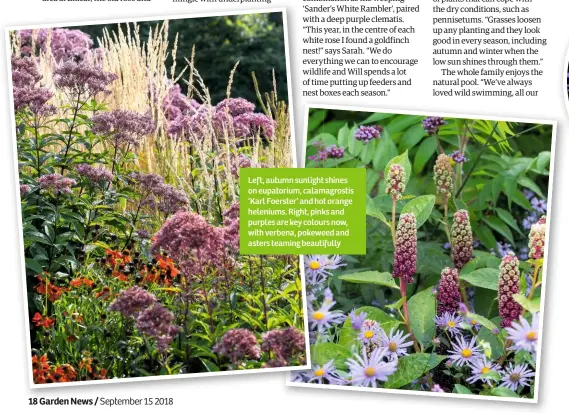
70, 12, 288, 103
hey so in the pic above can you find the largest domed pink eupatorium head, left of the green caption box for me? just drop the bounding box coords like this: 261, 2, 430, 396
152, 211, 225, 276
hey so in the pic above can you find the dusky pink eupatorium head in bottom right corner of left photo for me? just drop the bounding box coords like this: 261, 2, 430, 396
261, 327, 306, 366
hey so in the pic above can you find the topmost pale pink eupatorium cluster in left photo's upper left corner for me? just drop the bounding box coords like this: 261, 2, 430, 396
18, 28, 93, 62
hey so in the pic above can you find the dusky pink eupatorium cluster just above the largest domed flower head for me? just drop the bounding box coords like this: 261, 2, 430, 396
130, 172, 189, 215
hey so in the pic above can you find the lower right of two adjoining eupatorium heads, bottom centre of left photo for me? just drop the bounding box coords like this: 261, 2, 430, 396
136, 303, 180, 353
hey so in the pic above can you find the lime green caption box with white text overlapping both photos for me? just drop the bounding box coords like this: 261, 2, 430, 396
239, 168, 366, 255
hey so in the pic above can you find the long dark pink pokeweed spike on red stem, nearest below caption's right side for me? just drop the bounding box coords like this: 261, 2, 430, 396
393, 213, 417, 283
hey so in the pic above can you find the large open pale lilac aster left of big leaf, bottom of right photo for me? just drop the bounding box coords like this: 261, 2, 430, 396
346, 348, 397, 388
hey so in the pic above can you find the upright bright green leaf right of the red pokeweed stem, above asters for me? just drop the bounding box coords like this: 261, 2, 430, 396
407, 287, 436, 344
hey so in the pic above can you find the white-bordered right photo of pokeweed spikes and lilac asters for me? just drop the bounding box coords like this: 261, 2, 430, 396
292, 109, 552, 398
